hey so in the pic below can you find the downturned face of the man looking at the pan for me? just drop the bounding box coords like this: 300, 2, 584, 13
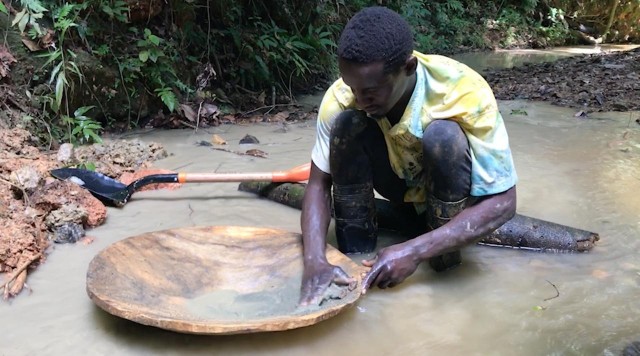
338, 58, 407, 117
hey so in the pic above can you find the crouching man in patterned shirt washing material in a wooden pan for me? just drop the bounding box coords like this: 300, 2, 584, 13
300, 7, 517, 305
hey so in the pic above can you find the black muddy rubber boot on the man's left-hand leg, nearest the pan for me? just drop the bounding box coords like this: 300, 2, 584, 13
333, 183, 378, 253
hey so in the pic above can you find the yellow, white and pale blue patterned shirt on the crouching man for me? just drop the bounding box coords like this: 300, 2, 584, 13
311, 52, 517, 211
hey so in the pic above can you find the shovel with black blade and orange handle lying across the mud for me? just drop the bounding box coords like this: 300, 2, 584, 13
49, 163, 311, 206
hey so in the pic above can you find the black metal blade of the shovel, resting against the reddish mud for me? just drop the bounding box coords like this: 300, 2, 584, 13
49, 168, 131, 206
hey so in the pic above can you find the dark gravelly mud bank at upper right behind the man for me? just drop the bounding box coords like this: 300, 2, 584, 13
485, 48, 640, 112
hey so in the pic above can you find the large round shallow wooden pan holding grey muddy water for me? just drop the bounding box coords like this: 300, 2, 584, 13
87, 226, 362, 334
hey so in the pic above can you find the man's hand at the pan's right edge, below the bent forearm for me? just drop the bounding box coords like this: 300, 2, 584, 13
362, 244, 420, 294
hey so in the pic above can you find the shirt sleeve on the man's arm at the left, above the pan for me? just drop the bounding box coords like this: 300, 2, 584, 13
311, 88, 344, 174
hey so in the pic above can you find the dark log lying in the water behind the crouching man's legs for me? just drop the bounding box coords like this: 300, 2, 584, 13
238, 182, 600, 252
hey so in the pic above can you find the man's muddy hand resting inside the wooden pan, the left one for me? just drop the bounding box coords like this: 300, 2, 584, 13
300, 261, 356, 306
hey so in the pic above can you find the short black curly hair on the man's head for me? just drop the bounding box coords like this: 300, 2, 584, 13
338, 6, 413, 73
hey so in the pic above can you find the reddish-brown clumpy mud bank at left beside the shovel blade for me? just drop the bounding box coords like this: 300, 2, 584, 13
0, 128, 167, 299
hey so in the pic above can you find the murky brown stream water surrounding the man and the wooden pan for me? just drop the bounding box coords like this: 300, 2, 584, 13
0, 49, 640, 355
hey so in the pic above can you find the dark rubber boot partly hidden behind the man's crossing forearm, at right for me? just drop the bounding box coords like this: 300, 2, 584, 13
426, 196, 467, 272
